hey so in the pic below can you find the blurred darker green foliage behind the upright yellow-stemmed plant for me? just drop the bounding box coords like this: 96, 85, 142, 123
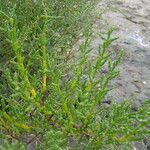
0, 0, 97, 62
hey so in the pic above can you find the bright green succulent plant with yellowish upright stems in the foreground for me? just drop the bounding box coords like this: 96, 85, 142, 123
0, 0, 150, 150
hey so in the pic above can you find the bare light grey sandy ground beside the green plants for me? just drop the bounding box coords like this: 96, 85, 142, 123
92, 0, 150, 150
